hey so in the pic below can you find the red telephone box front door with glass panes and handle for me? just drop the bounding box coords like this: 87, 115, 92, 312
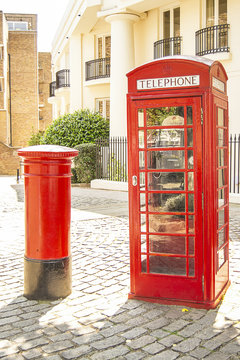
128, 96, 203, 302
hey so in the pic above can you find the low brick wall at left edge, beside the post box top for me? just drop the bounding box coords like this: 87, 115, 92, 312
0, 142, 20, 175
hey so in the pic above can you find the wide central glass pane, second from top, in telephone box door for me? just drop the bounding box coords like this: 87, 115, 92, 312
147, 129, 184, 148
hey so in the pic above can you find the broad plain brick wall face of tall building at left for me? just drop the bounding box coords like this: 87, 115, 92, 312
8, 31, 38, 147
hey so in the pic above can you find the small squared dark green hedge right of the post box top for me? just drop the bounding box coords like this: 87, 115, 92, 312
72, 144, 96, 183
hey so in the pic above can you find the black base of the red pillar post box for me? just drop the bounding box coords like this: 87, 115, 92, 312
24, 257, 72, 300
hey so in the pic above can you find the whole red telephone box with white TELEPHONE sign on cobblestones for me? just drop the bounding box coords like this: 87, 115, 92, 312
127, 56, 230, 308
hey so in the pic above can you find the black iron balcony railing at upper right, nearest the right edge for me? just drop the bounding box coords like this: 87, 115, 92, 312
196, 24, 230, 55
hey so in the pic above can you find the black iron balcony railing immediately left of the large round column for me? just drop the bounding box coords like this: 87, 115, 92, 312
86, 58, 111, 80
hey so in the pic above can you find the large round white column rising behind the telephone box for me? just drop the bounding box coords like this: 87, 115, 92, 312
106, 13, 139, 136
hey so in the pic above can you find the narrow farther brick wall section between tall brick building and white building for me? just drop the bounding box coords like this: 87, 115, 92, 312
38, 52, 52, 130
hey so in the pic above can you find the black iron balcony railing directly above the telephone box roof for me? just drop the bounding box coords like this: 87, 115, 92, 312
154, 36, 182, 59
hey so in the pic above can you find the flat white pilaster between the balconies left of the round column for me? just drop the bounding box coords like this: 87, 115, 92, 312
70, 34, 83, 112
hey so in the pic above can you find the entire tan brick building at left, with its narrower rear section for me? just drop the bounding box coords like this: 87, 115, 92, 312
0, 11, 52, 174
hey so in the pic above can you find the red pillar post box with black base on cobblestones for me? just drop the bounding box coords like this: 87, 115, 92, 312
18, 145, 78, 300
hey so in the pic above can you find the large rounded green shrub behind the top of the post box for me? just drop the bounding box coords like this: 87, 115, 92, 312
41, 109, 109, 148
